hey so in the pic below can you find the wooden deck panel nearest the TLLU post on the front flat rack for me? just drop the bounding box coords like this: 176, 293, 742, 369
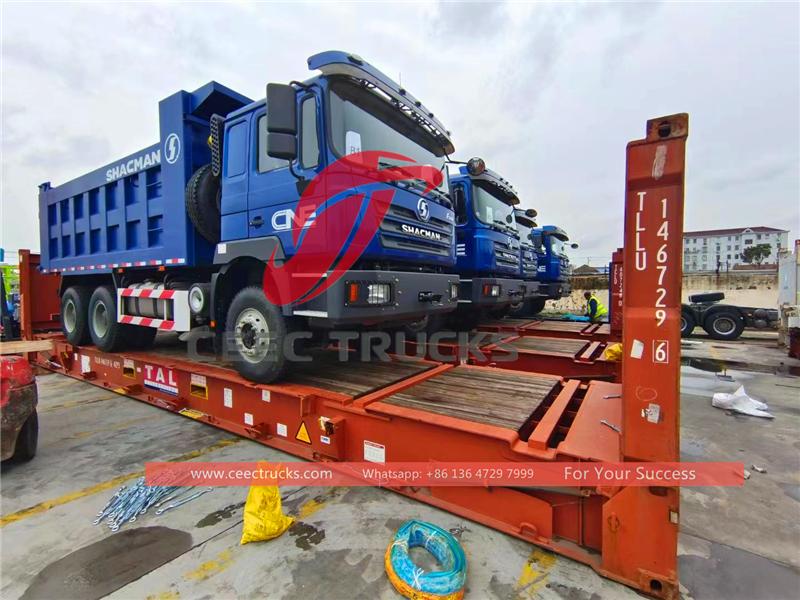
381, 367, 559, 431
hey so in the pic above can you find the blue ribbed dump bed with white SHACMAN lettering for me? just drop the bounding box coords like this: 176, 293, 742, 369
39, 81, 252, 273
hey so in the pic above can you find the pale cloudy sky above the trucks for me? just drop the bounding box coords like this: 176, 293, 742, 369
0, 1, 800, 265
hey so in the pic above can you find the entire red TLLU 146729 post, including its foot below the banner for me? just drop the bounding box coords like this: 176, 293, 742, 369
602, 114, 688, 599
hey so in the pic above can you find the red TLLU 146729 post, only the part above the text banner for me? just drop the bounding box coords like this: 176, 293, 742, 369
622, 114, 689, 461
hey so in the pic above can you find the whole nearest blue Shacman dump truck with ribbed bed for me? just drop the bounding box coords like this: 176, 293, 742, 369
39, 51, 462, 382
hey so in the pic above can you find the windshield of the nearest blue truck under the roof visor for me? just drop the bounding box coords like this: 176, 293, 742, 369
329, 80, 448, 199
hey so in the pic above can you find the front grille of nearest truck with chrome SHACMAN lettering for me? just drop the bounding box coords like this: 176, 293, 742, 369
380, 205, 453, 256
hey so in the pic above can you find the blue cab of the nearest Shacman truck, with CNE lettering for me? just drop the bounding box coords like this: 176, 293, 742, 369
215, 52, 457, 326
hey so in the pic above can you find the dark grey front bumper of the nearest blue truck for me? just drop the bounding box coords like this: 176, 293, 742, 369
287, 271, 458, 327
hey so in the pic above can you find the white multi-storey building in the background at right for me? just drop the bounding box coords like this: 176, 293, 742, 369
683, 226, 789, 273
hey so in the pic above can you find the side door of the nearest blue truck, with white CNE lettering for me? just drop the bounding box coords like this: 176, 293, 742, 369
247, 92, 324, 255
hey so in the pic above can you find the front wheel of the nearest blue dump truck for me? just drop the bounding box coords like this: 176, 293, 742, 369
225, 286, 290, 383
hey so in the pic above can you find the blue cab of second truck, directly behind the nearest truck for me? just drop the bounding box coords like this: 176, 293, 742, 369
450, 158, 527, 319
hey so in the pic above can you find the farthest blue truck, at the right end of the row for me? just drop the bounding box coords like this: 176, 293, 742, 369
525, 225, 578, 316
